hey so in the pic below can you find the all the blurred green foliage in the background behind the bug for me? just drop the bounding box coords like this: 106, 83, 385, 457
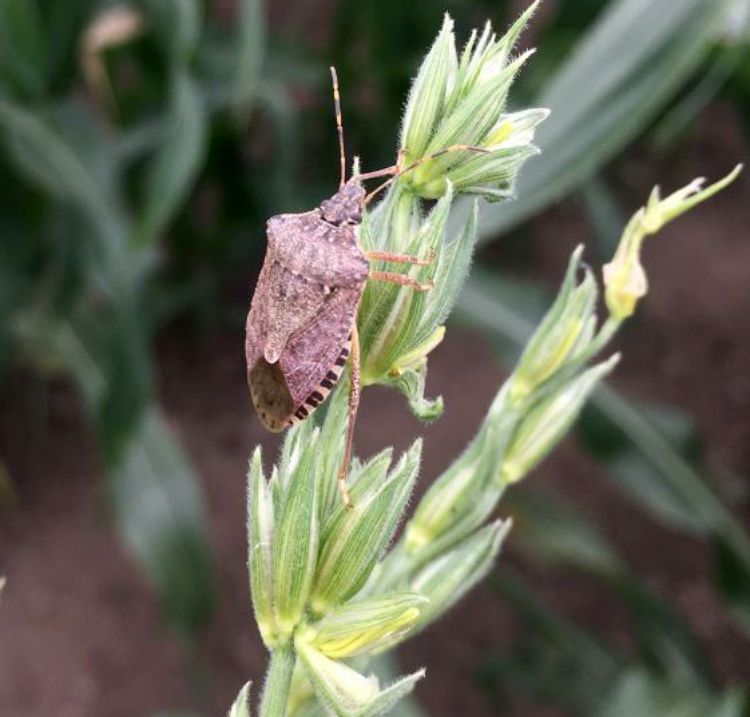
0, 0, 750, 716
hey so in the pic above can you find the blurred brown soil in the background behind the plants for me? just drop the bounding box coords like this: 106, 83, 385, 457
0, 107, 750, 717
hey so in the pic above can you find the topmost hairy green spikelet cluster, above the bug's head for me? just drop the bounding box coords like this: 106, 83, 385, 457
400, 11, 546, 201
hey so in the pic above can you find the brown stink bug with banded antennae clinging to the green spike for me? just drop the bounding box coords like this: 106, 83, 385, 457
245, 67, 488, 506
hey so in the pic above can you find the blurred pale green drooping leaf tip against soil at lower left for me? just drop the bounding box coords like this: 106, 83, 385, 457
50, 326, 215, 635
